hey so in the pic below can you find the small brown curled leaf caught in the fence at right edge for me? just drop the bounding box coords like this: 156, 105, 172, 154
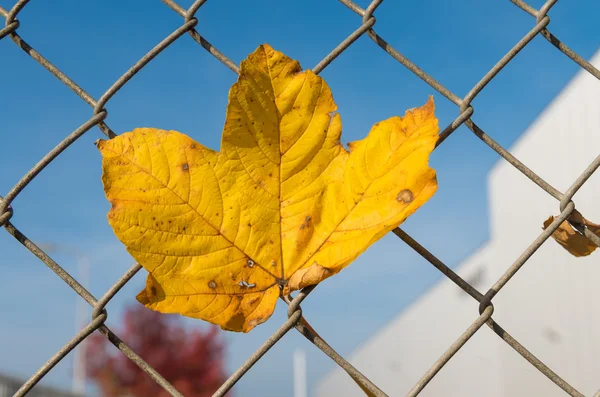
543, 210, 600, 257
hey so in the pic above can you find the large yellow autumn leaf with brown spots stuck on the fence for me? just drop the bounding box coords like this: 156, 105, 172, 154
98, 45, 439, 332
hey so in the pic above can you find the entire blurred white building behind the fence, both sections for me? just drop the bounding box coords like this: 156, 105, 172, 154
317, 52, 600, 397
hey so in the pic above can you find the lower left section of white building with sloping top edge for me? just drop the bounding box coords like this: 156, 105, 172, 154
317, 245, 502, 397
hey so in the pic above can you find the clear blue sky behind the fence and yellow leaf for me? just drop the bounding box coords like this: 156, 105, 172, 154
0, 0, 600, 397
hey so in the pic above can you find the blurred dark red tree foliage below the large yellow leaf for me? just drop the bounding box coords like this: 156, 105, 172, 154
87, 305, 230, 397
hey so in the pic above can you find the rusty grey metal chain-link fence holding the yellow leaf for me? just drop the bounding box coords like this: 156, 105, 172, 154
0, 0, 600, 396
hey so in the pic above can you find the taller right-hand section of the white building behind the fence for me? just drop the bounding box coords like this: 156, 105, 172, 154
489, 50, 600, 396
